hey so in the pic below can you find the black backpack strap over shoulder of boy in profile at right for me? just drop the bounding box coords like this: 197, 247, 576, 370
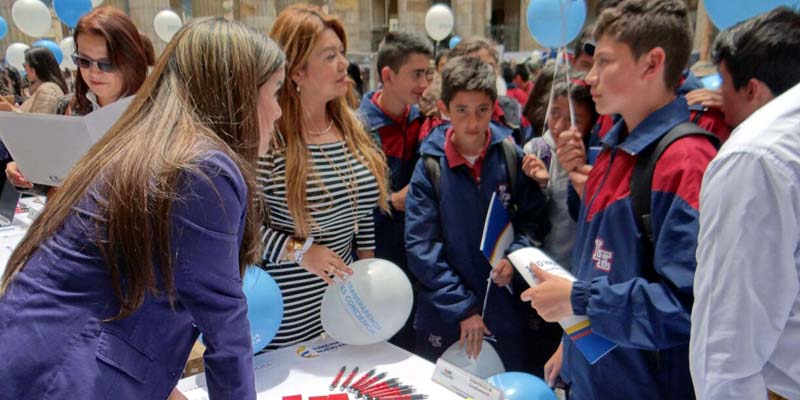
631, 122, 719, 282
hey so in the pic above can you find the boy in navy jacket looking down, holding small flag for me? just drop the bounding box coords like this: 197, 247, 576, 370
405, 57, 549, 370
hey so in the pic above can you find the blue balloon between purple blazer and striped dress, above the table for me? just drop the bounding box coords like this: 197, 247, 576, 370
242, 265, 283, 354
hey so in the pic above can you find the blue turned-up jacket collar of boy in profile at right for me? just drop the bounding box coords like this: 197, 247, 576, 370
602, 96, 689, 155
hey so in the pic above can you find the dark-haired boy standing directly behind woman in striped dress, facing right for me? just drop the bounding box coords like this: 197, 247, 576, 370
358, 31, 433, 350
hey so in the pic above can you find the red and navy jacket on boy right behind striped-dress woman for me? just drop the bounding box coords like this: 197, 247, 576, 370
358, 91, 424, 271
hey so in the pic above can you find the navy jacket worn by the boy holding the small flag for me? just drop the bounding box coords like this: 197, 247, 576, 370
405, 123, 550, 368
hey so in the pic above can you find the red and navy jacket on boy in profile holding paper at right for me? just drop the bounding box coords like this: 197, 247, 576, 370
562, 96, 716, 399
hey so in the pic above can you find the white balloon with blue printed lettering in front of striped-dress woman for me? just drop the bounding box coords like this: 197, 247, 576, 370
322, 258, 414, 345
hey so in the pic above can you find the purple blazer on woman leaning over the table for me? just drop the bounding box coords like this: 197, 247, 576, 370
0, 151, 256, 400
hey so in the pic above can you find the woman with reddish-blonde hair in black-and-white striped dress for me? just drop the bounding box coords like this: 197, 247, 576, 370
259, 4, 388, 349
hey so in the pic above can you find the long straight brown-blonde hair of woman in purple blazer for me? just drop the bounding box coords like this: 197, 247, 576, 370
1, 19, 284, 318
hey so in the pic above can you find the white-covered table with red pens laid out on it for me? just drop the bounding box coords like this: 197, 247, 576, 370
178, 338, 462, 400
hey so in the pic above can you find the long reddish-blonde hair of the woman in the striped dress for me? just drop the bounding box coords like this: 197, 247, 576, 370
270, 4, 389, 237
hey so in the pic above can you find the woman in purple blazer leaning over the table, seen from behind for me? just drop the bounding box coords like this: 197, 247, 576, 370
0, 19, 285, 399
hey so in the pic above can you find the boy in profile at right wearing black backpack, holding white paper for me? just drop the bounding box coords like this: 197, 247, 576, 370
523, 0, 716, 400
